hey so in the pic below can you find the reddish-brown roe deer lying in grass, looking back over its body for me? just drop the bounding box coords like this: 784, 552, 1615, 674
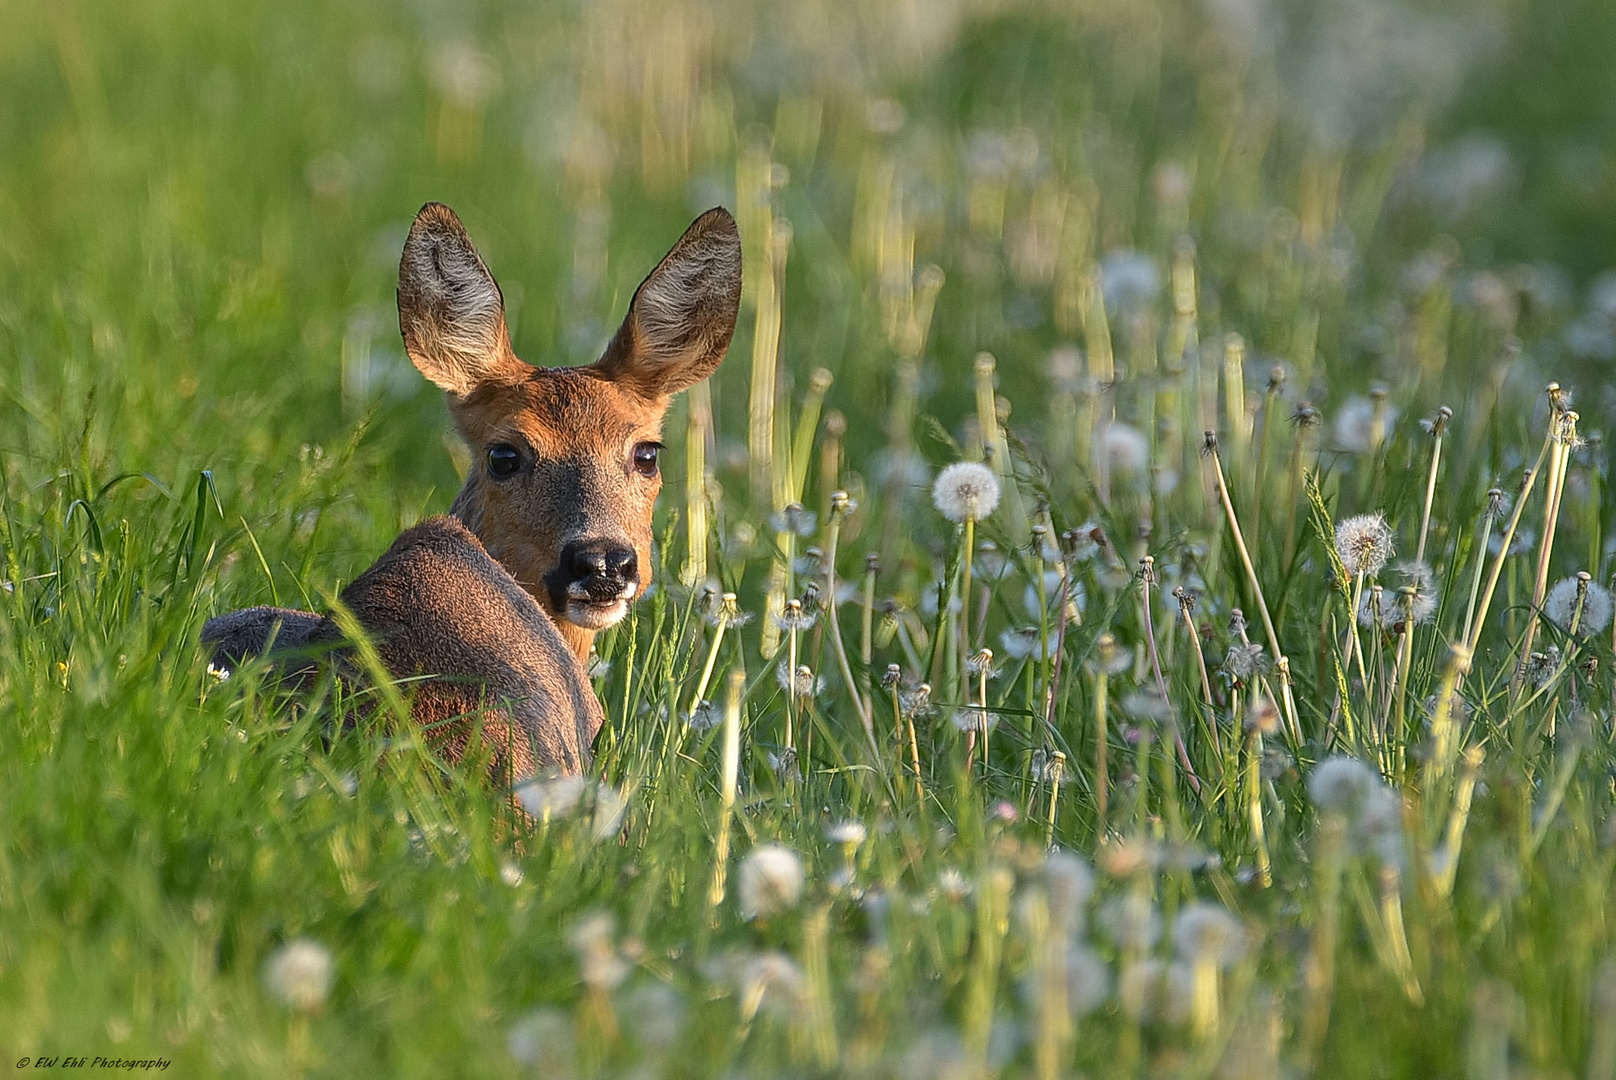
202, 202, 740, 784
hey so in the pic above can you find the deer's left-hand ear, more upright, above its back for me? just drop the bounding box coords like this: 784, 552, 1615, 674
399, 202, 527, 398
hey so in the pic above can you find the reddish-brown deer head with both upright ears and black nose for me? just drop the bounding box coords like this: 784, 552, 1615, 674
399, 202, 740, 658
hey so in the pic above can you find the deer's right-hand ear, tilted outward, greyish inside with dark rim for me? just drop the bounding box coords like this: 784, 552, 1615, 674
595, 207, 740, 399
